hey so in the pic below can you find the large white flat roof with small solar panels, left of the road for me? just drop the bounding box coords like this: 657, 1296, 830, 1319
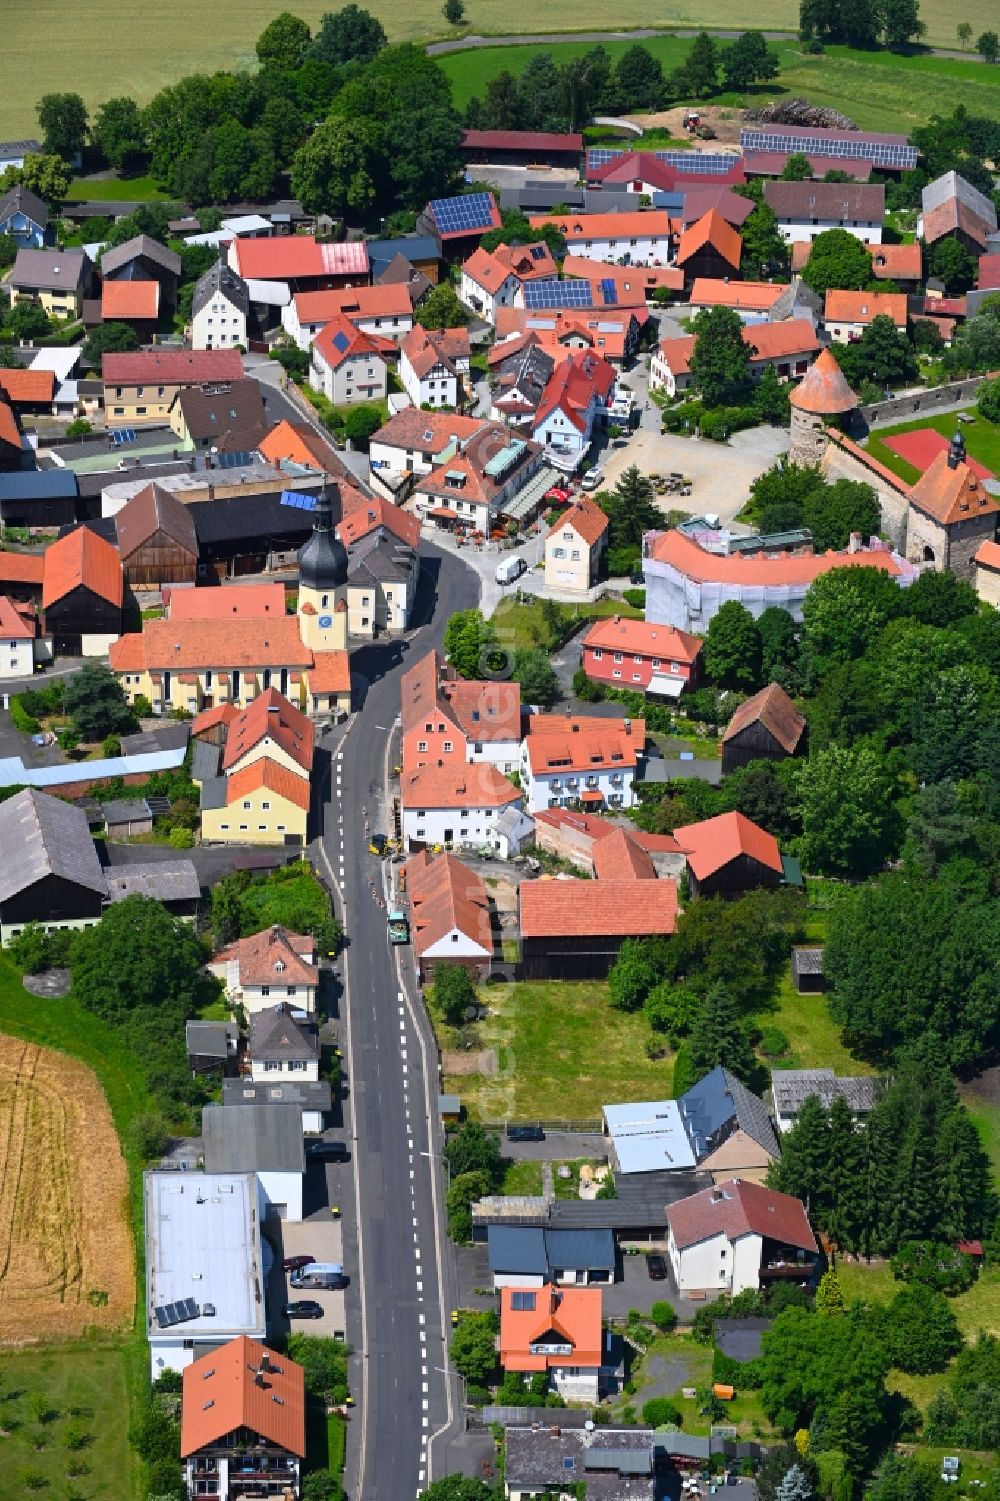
143, 1171, 266, 1342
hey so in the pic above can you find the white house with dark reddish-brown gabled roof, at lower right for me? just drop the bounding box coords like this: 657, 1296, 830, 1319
667, 1178, 820, 1297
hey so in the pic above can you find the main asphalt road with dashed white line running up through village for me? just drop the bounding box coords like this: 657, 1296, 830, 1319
317, 546, 479, 1501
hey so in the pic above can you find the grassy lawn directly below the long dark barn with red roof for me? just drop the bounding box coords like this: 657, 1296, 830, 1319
444, 982, 673, 1121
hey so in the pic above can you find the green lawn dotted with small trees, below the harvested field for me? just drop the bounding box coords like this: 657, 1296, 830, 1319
0, 1342, 134, 1501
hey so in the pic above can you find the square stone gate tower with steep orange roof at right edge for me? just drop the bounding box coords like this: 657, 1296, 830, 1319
907, 432, 1000, 584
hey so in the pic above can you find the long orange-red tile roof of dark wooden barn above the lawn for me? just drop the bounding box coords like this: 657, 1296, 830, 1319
518, 876, 677, 938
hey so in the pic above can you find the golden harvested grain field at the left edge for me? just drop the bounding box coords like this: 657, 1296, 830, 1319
0, 1033, 135, 1343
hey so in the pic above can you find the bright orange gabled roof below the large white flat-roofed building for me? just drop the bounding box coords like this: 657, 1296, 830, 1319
180, 1334, 305, 1459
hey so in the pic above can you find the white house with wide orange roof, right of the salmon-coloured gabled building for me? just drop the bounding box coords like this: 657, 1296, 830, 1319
521, 714, 646, 814
